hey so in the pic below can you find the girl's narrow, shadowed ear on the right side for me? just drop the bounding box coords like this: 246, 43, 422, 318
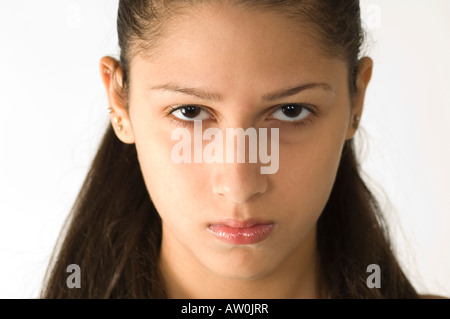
346, 57, 373, 140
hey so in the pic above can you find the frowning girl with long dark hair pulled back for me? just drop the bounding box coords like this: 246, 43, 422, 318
41, 0, 434, 298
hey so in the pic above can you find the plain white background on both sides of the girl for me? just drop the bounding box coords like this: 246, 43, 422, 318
0, 0, 450, 298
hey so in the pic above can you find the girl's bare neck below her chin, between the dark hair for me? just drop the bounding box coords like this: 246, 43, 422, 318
159, 227, 319, 299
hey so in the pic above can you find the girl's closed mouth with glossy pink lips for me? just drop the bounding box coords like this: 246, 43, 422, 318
208, 220, 274, 245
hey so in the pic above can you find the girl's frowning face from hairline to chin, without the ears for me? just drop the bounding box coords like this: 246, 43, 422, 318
109, 6, 362, 279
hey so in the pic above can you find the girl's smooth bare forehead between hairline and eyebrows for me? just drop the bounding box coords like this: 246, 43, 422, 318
131, 5, 343, 92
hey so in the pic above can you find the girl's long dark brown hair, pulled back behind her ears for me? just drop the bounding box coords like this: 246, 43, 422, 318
41, 0, 418, 298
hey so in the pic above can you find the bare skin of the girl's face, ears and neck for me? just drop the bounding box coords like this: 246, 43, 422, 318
100, 4, 372, 298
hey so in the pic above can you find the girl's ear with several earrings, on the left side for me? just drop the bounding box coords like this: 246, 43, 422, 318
100, 56, 135, 144
